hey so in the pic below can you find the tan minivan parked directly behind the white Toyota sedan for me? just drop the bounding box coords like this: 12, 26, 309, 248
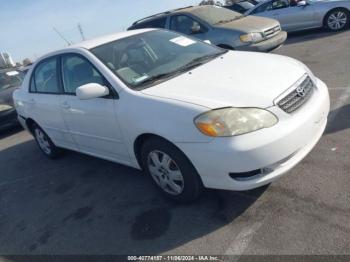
128, 6, 287, 52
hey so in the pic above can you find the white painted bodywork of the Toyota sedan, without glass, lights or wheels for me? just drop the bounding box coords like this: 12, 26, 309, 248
14, 30, 329, 190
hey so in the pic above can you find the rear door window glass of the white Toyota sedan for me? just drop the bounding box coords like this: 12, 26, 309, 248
30, 57, 61, 94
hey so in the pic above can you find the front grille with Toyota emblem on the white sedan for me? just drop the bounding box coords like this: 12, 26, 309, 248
278, 76, 314, 114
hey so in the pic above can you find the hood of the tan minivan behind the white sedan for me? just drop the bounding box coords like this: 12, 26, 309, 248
216, 16, 279, 33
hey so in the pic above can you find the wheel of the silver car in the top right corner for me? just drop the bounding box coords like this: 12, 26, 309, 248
324, 8, 350, 32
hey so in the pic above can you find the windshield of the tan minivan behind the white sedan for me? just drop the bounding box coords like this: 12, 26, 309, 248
191, 6, 242, 25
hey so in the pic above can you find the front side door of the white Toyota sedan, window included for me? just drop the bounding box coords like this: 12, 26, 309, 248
60, 54, 130, 163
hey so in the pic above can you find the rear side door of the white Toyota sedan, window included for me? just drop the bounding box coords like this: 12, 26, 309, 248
24, 57, 77, 149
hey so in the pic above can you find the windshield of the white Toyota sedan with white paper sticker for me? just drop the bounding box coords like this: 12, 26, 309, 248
90, 30, 225, 89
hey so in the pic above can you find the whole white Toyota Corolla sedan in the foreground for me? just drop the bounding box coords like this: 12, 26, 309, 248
14, 29, 329, 201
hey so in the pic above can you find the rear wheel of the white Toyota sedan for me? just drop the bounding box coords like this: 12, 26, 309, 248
31, 124, 61, 159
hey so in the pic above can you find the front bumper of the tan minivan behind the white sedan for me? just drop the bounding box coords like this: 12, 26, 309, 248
236, 31, 287, 52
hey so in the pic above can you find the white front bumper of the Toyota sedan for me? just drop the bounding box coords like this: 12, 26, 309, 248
177, 80, 330, 191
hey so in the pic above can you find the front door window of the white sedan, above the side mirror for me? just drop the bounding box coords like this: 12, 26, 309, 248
62, 55, 105, 94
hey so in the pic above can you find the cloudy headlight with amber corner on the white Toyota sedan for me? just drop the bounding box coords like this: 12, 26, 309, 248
194, 108, 278, 137
